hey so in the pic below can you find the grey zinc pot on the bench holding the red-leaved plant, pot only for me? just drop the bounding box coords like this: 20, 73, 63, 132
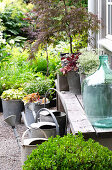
67, 71, 81, 94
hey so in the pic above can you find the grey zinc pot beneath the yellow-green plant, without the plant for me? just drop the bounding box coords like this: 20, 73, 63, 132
2, 99, 24, 123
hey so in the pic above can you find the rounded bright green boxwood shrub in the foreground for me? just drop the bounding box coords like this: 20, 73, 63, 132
23, 134, 112, 170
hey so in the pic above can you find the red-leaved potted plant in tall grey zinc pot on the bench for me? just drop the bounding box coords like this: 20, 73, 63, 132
60, 53, 81, 94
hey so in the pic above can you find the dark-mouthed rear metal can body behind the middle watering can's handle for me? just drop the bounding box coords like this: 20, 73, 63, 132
40, 110, 66, 136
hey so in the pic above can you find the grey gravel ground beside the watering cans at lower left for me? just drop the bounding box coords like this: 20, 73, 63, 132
0, 113, 26, 170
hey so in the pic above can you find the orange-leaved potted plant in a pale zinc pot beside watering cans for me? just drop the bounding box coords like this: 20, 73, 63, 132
22, 92, 49, 126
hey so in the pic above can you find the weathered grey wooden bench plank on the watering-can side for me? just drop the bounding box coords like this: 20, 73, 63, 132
61, 91, 95, 134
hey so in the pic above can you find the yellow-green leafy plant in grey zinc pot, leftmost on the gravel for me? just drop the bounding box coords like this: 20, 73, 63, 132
1, 88, 26, 123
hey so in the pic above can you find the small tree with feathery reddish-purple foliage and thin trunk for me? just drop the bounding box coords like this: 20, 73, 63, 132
24, 0, 99, 75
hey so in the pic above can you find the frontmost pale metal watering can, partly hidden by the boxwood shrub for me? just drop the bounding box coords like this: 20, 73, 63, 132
21, 129, 47, 165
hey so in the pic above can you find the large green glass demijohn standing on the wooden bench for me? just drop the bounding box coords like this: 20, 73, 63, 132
82, 55, 112, 128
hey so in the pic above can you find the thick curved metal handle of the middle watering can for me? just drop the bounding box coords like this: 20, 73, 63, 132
37, 108, 59, 135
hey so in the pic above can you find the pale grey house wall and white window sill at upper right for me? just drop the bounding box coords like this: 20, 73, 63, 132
88, 0, 112, 68
